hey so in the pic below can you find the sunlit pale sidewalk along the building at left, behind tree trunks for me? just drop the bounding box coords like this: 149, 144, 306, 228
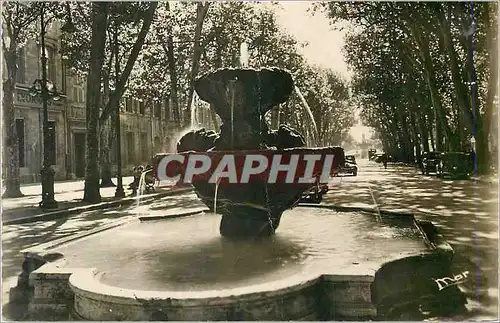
2, 177, 191, 225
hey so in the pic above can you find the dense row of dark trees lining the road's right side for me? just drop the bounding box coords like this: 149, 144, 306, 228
323, 2, 498, 172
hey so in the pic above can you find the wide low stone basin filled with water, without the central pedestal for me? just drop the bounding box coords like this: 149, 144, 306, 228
27, 205, 453, 320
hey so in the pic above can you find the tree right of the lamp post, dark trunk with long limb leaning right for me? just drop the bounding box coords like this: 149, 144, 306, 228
62, 2, 158, 201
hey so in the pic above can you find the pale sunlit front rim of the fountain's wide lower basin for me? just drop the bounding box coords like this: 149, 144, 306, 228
65, 224, 442, 306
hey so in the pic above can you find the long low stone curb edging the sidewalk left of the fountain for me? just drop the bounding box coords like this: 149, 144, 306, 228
2, 187, 193, 225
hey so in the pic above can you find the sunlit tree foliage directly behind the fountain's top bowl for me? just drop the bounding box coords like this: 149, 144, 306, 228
129, 2, 353, 145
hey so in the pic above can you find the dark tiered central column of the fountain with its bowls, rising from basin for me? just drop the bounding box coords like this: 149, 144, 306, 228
157, 68, 344, 237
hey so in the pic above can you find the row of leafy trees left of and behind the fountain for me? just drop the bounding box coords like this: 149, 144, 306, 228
3, 2, 353, 202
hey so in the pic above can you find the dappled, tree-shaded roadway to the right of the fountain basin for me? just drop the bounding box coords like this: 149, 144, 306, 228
324, 165, 498, 319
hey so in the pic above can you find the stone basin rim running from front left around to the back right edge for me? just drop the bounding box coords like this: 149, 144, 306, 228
64, 210, 453, 305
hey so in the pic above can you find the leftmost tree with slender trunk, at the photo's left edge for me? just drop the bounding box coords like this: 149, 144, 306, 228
2, 1, 40, 198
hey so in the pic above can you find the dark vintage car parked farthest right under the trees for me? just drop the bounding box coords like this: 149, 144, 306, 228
437, 152, 474, 178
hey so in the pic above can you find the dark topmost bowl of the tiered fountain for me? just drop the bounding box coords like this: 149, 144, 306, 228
195, 68, 294, 121
